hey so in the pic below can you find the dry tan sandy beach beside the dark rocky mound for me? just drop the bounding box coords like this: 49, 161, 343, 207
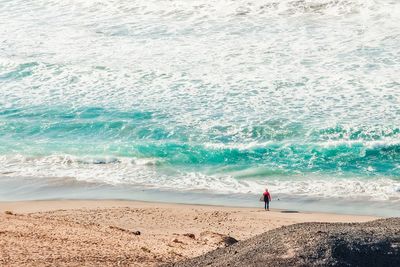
0, 200, 377, 266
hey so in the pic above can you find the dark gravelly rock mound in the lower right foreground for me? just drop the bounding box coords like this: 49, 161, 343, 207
171, 218, 400, 267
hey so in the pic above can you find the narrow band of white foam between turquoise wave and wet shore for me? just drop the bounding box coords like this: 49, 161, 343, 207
0, 156, 400, 203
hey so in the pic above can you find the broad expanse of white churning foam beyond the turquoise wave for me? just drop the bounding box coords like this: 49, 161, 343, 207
0, 0, 400, 133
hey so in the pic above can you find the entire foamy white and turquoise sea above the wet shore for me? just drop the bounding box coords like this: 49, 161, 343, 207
0, 0, 400, 208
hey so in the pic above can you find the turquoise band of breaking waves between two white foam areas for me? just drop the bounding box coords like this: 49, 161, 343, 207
0, 107, 400, 179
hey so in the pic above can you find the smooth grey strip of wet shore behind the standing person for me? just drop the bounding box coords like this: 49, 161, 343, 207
0, 176, 400, 217
